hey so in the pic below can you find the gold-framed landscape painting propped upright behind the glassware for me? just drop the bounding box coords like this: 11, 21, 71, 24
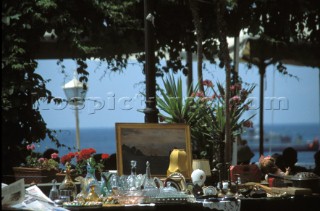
116, 123, 192, 179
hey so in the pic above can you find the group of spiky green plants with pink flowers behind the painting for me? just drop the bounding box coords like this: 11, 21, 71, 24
157, 75, 255, 159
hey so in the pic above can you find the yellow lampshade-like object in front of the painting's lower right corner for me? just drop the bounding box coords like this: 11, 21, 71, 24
167, 149, 189, 177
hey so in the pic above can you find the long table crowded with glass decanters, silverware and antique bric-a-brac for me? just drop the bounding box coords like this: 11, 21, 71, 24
2, 160, 320, 211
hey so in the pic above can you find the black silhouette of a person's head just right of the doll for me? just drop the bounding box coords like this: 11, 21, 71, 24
282, 147, 308, 175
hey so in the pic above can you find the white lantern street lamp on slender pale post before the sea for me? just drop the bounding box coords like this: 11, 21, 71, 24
62, 71, 87, 151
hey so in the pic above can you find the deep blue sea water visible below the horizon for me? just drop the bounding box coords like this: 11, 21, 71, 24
36, 124, 320, 168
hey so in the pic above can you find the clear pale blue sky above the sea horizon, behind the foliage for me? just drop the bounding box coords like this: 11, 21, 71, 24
37, 60, 320, 129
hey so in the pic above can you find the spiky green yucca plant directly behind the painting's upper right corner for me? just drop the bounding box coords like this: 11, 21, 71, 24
157, 75, 212, 157
